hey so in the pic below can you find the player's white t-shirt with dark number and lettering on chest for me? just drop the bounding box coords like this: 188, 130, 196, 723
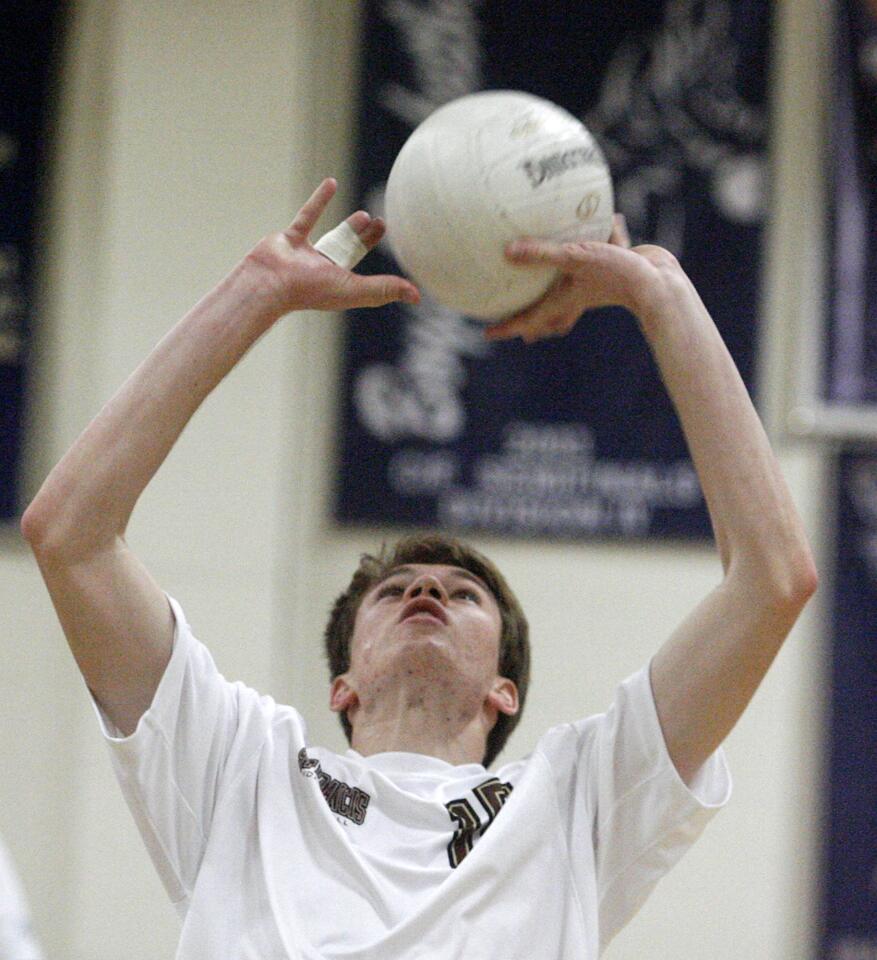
99, 601, 730, 960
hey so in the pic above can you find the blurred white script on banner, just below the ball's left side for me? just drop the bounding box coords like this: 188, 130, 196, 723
353, 297, 488, 443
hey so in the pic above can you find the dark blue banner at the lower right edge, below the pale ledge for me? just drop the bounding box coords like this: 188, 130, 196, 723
820, 450, 877, 960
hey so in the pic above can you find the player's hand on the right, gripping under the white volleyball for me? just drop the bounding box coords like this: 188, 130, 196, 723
485, 214, 678, 343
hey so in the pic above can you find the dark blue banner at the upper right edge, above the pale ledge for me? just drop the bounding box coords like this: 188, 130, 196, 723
821, 0, 877, 407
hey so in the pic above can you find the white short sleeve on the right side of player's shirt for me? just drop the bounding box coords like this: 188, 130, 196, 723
546, 666, 731, 948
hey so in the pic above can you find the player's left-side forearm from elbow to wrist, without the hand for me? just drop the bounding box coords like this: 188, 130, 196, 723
22, 261, 277, 560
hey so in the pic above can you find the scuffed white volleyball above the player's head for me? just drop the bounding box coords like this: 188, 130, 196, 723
385, 90, 613, 321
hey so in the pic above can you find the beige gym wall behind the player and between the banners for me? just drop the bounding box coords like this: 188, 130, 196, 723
0, 0, 824, 960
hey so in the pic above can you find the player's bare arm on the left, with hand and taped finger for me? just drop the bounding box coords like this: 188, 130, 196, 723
21, 180, 418, 734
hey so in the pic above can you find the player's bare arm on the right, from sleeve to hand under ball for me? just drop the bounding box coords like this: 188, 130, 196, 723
488, 229, 816, 780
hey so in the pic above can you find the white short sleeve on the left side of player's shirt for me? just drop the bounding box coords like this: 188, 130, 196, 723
94, 598, 272, 904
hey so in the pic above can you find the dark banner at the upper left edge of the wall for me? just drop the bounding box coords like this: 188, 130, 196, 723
0, 0, 62, 520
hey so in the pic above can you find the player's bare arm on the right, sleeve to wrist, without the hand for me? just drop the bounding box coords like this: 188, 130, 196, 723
639, 260, 816, 780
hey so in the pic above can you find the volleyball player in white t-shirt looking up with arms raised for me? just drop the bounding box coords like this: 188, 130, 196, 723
23, 181, 815, 960
